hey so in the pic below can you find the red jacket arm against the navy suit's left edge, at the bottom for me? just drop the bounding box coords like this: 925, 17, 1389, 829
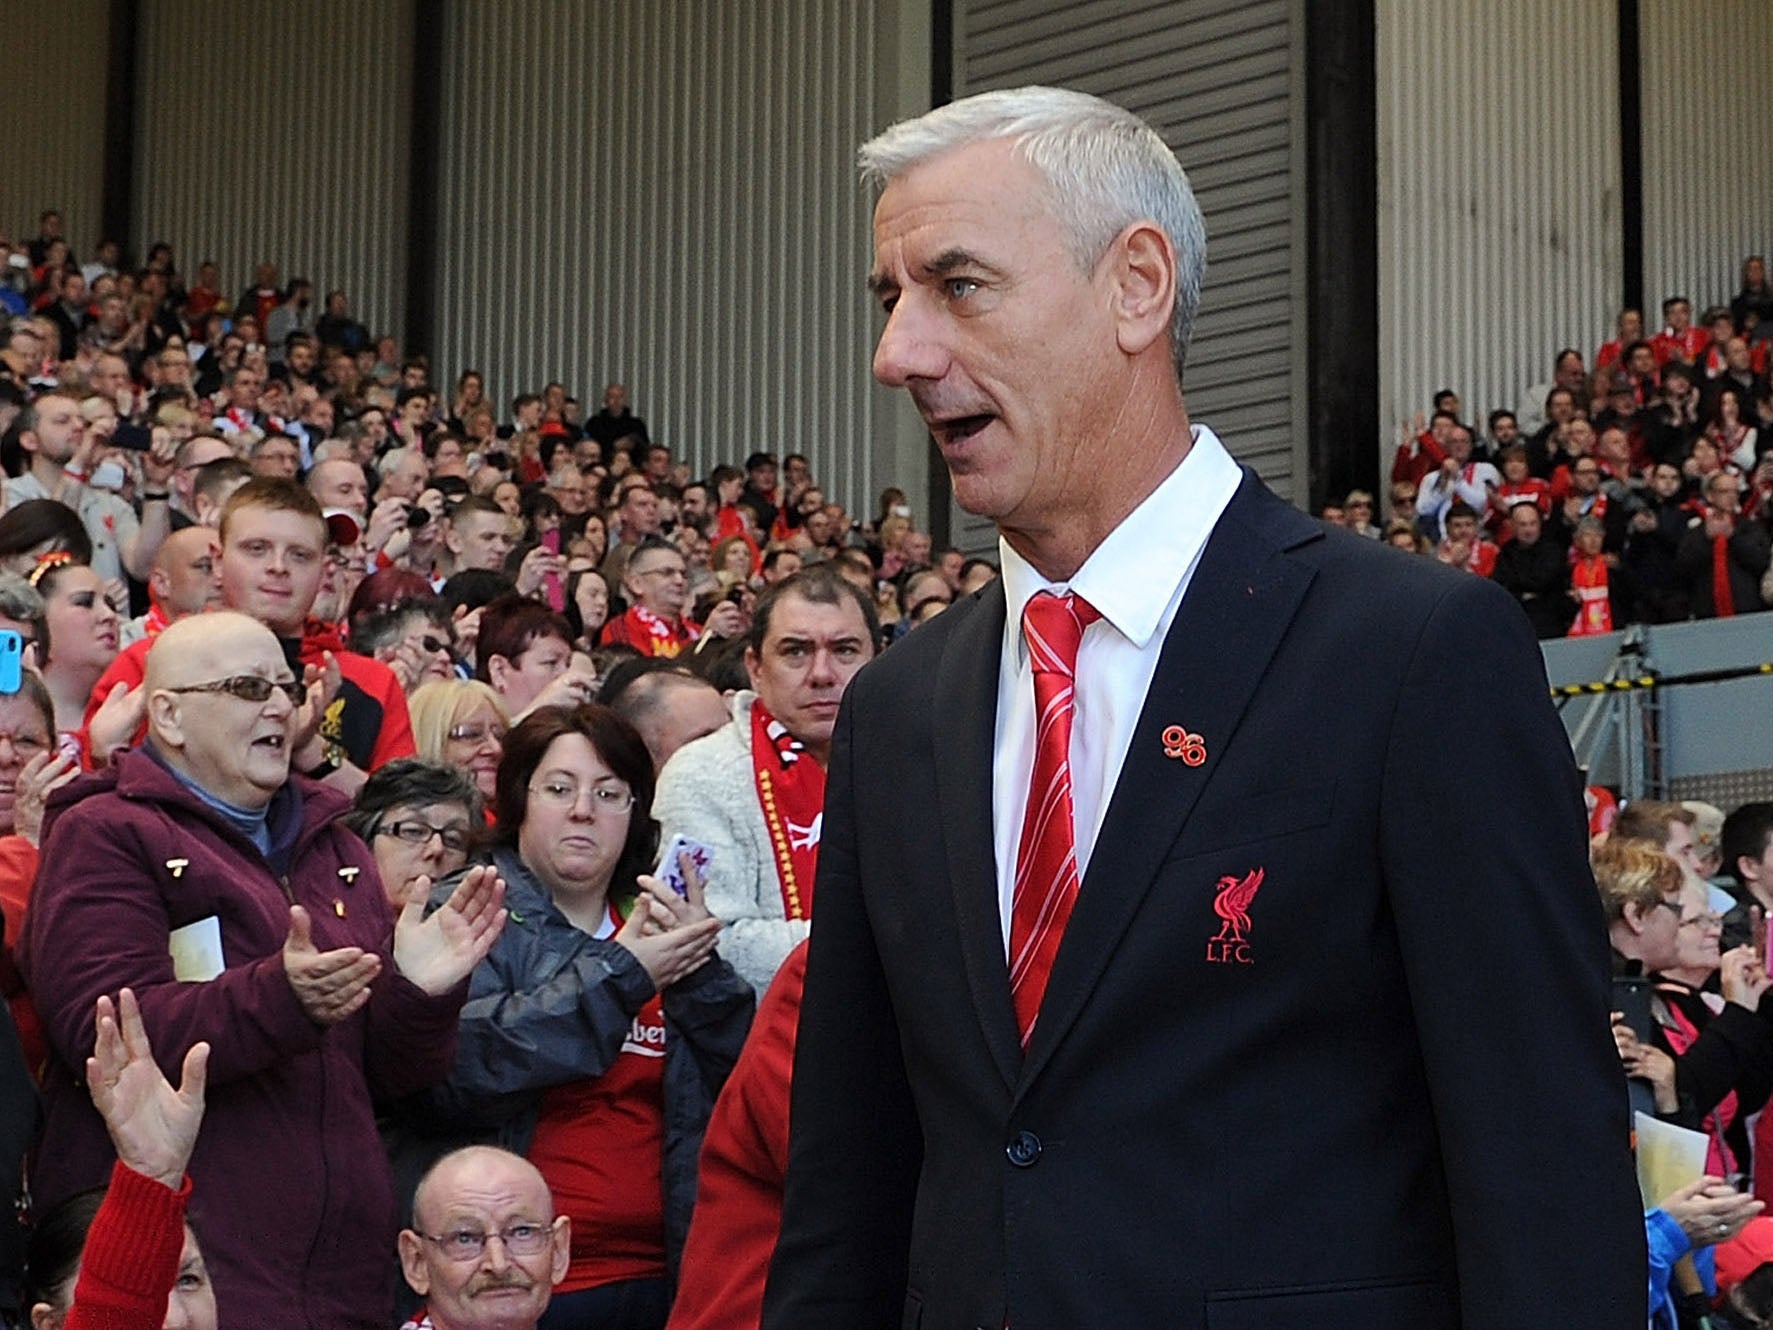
665, 942, 807, 1330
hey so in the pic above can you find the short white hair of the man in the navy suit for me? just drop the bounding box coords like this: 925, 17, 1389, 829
856, 87, 1207, 378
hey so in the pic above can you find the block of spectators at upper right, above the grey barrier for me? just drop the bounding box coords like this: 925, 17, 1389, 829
1323, 255, 1773, 638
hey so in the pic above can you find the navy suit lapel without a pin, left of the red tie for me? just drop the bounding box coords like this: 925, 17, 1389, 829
931, 582, 1021, 1089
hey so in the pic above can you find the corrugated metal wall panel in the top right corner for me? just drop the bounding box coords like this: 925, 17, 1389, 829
1638, 0, 1773, 326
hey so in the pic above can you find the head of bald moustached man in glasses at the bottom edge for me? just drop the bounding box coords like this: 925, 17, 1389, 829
401, 1146, 573, 1330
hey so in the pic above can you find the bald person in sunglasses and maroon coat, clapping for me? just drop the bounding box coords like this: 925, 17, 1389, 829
23, 610, 504, 1330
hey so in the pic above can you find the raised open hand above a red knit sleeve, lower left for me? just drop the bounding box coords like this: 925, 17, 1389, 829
87, 988, 209, 1190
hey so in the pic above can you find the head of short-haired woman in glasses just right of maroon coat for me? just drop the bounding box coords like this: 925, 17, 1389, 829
344, 757, 482, 911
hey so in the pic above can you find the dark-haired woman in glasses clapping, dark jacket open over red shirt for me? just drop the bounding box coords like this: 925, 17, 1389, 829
411, 706, 752, 1330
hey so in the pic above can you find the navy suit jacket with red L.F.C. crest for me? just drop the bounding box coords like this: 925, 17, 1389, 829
762, 472, 1645, 1330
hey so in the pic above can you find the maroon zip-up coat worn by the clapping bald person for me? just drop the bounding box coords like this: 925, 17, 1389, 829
23, 750, 466, 1330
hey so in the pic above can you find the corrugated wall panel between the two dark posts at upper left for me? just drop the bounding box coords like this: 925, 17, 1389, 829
135, 0, 417, 344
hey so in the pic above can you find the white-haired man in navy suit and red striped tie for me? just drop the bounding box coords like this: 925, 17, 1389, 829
769, 89, 1645, 1330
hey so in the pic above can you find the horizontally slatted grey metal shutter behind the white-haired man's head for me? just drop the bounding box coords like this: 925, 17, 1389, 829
954, 0, 1307, 546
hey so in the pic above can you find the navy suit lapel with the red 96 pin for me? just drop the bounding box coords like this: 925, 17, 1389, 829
1019, 470, 1323, 1087
